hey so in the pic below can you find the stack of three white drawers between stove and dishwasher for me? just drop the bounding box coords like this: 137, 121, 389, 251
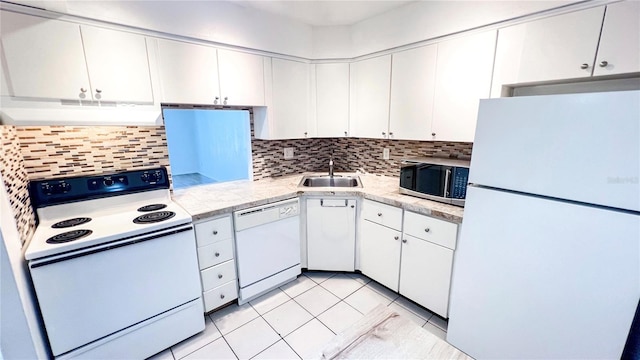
195, 215, 238, 312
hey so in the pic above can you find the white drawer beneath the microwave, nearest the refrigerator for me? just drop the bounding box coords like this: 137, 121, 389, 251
404, 211, 458, 250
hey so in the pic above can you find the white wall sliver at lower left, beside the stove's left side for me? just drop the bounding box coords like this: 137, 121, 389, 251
0, 176, 48, 359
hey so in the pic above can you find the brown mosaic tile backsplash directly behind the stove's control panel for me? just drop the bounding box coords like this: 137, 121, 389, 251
17, 126, 170, 180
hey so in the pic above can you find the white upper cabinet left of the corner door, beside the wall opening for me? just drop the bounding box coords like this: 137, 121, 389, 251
254, 58, 315, 140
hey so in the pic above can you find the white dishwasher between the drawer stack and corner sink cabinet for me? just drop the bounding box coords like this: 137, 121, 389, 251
233, 198, 301, 304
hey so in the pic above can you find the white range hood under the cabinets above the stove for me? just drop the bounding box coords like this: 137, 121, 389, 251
0, 106, 163, 126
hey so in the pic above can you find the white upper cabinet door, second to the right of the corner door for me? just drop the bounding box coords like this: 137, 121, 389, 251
389, 45, 438, 140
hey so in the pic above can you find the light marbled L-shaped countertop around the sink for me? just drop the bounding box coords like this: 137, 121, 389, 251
173, 173, 464, 224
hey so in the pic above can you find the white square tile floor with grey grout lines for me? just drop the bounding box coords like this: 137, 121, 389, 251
151, 271, 447, 360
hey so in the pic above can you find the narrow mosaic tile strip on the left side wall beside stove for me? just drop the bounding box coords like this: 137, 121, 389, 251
0, 125, 36, 245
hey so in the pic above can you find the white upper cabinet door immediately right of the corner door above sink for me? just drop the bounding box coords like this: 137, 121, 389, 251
349, 55, 391, 139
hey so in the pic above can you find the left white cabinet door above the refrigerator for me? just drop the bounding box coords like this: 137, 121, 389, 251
490, 6, 604, 97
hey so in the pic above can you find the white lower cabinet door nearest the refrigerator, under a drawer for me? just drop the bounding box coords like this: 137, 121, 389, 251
400, 234, 453, 318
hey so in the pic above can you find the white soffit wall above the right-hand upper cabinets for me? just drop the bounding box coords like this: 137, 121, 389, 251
351, 0, 577, 56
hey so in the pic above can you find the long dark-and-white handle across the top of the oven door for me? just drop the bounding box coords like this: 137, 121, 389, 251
29, 224, 193, 269
